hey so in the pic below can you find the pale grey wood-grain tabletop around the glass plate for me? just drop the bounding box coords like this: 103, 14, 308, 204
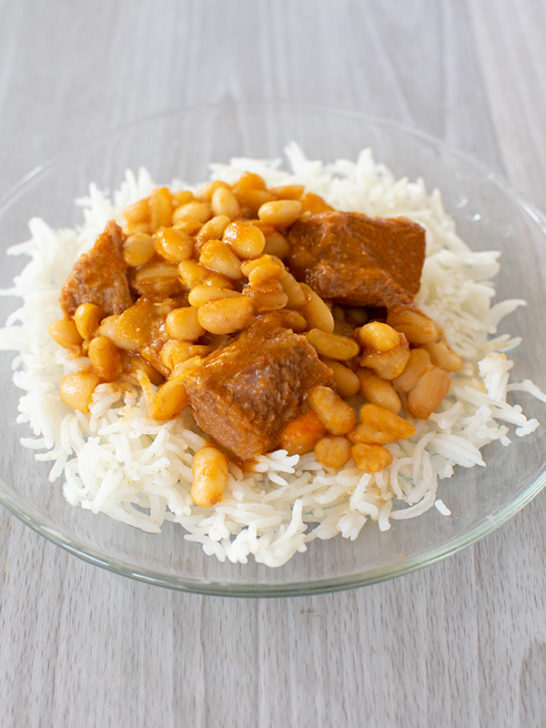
0, 0, 546, 728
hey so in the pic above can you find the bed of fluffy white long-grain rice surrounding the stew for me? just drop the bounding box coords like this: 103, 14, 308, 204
0, 143, 546, 566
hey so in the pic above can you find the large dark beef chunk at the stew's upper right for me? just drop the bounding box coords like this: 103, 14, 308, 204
289, 212, 425, 307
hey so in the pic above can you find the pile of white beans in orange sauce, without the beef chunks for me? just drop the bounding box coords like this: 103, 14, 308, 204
49, 173, 462, 506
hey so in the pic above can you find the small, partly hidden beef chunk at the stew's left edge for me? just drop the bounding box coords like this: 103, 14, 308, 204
60, 220, 133, 316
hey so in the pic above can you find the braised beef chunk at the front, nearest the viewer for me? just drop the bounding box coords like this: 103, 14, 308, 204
185, 316, 332, 460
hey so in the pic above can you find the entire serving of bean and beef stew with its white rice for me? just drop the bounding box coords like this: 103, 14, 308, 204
0, 144, 544, 566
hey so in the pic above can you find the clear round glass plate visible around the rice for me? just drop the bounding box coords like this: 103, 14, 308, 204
0, 104, 546, 596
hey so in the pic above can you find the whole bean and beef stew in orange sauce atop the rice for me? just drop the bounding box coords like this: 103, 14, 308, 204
49, 173, 462, 507
